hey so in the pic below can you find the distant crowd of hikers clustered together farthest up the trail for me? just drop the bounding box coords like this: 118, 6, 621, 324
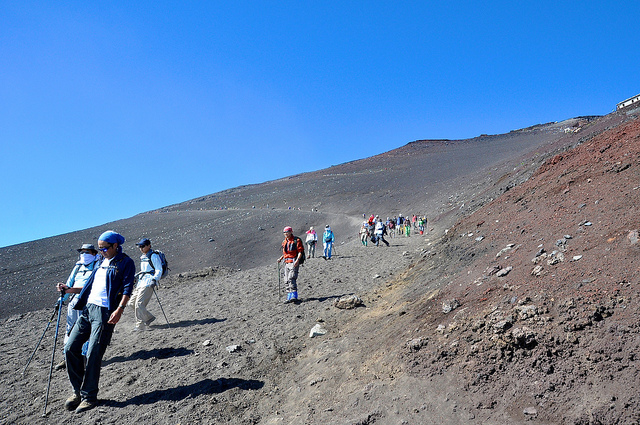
358, 214, 427, 246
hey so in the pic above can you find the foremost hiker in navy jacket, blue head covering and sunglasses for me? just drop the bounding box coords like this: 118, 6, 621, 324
59, 230, 136, 413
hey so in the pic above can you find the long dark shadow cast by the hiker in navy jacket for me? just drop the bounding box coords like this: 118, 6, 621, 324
101, 378, 264, 407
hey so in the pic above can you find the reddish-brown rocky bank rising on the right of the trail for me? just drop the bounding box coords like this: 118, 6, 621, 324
402, 112, 640, 424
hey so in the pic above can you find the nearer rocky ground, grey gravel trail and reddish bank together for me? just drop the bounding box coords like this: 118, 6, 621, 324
0, 112, 640, 424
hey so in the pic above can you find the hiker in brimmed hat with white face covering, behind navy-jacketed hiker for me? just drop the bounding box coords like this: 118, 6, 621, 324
56, 243, 102, 370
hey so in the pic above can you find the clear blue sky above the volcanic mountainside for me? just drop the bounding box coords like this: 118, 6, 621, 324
0, 0, 640, 246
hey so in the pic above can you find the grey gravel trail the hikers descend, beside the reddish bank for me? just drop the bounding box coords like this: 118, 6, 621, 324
0, 219, 436, 424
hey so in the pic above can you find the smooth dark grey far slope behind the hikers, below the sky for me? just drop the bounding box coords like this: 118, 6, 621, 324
0, 117, 600, 318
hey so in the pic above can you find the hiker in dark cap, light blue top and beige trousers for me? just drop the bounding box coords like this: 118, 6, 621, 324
129, 238, 162, 331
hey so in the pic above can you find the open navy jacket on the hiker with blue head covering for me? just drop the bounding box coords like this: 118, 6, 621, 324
74, 252, 136, 312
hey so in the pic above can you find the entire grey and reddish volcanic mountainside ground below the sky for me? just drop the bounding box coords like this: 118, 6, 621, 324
5, 111, 640, 424
